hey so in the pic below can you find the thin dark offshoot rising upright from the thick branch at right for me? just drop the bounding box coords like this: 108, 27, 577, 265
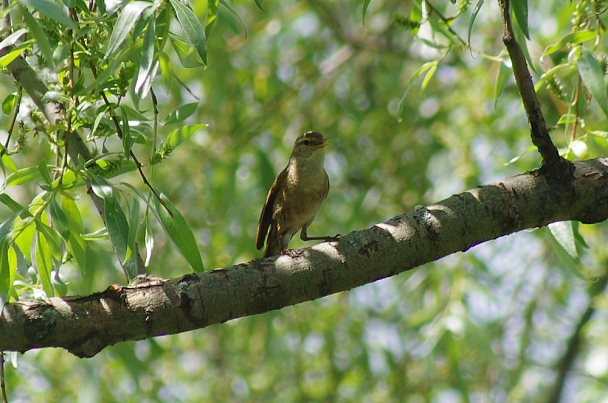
498, 0, 573, 179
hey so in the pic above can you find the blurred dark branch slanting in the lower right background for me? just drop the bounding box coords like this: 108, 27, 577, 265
547, 276, 608, 402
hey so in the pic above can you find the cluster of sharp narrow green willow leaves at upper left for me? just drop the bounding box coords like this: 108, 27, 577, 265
0, 0, 230, 300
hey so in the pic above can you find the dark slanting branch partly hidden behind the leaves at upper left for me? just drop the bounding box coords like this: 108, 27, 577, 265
0, 0, 145, 278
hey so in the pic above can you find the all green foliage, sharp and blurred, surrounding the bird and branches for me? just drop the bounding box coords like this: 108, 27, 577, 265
0, 0, 608, 401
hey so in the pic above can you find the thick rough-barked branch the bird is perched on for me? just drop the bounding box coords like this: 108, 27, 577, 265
0, 158, 608, 357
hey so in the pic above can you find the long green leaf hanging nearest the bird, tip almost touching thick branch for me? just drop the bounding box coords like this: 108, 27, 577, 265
154, 194, 205, 272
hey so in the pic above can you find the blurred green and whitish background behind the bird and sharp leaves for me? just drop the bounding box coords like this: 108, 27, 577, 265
0, 0, 608, 402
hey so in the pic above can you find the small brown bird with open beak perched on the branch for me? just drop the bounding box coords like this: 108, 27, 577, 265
255, 132, 336, 257
